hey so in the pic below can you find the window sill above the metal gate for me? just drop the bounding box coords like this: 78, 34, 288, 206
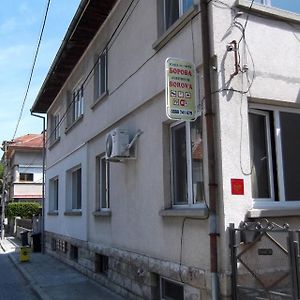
247, 207, 300, 219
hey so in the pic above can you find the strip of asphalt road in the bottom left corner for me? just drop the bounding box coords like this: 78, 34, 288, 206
0, 247, 38, 300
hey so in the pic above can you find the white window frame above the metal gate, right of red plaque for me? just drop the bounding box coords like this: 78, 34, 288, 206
249, 104, 300, 208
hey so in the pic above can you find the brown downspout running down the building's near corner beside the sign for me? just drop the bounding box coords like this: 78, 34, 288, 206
200, 0, 219, 300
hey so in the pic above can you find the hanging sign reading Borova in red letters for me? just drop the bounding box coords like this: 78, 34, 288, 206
165, 58, 196, 121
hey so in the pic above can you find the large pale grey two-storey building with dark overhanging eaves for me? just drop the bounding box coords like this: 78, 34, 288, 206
32, 0, 300, 299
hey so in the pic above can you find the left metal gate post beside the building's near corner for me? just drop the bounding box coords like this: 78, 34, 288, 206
229, 223, 237, 300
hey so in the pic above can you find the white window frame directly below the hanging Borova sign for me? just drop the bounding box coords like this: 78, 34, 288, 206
170, 119, 205, 208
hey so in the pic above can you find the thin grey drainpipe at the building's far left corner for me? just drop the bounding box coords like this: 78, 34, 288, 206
30, 111, 46, 254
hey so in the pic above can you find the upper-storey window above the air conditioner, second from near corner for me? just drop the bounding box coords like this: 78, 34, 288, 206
95, 50, 107, 101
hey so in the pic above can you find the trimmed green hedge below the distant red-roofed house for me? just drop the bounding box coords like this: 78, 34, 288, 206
6, 202, 41, 219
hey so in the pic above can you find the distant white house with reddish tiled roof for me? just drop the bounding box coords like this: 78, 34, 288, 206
6, 134, 43, 202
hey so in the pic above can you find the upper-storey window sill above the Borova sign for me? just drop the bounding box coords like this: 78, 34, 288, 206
152, 6, 198, 51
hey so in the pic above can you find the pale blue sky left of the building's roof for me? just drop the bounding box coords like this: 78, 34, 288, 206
0, 0, 80, 143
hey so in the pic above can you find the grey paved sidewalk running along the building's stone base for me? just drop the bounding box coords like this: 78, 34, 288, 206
1, 237, 123, 300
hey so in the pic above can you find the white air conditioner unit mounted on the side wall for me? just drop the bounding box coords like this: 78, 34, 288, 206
106, 127, 129, 159
